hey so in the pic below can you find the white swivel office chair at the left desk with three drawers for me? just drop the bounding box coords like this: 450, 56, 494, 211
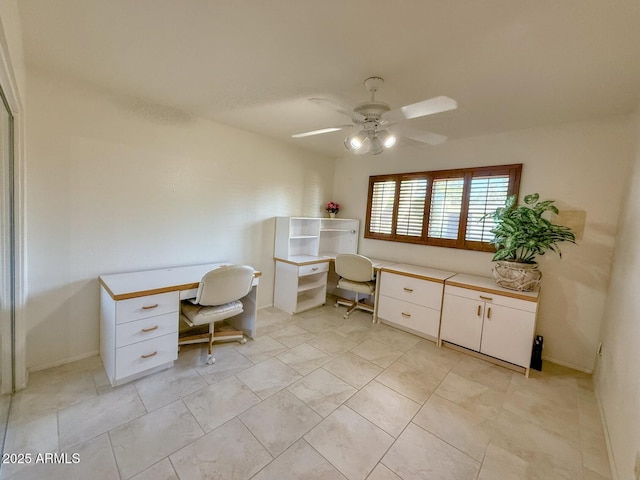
178, 265, 254, 365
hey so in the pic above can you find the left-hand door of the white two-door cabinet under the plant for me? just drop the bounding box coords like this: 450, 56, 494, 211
440, 294, 484, 351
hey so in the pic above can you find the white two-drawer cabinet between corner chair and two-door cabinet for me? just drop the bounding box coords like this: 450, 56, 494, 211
377, 264, 454, 340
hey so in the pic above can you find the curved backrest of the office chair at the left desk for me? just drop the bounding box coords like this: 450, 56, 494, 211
196, 265, 254, 306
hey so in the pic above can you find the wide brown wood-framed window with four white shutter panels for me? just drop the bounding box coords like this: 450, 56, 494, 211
364, 164, 522, 251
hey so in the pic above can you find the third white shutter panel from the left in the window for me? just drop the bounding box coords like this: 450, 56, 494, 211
429, 178, 464, 240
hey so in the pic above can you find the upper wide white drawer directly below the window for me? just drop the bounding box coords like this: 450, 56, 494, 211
380, 272, 444, 310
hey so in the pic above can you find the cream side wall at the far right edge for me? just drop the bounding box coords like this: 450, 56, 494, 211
595, 111, 640, 479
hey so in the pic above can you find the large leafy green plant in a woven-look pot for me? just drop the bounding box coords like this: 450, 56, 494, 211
490, 193, 575, 291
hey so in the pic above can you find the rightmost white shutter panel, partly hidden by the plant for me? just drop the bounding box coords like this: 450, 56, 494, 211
465, 175, 509, 242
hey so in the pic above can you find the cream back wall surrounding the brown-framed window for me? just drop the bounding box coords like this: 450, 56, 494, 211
334, 116, 633, 371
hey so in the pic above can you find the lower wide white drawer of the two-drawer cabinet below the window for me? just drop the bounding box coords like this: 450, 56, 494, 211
378, 295, 440, 338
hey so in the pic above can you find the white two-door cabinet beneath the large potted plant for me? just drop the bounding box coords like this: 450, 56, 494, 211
440, 274, 538, 374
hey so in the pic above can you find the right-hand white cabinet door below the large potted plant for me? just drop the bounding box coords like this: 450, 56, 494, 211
480, 304, 536, 368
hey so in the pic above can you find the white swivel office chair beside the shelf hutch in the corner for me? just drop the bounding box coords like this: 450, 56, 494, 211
335, 253, 376, 318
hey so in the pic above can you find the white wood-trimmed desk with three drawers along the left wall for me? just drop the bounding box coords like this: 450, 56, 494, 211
98, 262, 261, 386
